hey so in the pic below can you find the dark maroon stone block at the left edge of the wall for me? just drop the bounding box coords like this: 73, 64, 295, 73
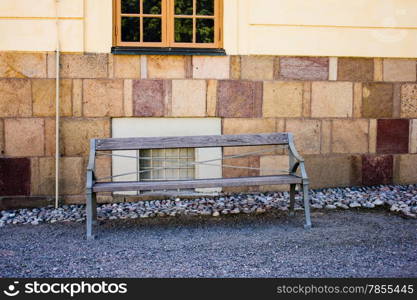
0, 158, 30, 196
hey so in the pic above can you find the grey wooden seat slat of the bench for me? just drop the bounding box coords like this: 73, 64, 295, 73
93, 175, 302, 192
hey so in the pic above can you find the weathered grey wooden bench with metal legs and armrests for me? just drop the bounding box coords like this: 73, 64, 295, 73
86, 133, 311, 239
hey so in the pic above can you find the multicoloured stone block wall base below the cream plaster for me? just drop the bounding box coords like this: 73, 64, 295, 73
0, 52, 417, 207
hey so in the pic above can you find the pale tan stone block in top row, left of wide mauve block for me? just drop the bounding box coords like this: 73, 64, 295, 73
241, 55, 274, 80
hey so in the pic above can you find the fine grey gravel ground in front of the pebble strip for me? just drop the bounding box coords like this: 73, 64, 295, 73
0, 208, 417, 277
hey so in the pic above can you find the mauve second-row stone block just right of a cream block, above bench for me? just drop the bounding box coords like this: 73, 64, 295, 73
217, 80, 263, 118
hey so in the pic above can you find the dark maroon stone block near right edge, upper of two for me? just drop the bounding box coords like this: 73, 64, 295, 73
376, 119, 409, 154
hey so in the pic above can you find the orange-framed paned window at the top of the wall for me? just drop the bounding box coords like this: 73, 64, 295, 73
115, 0, 223, 48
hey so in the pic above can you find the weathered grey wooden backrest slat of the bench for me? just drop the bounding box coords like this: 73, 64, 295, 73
96, 133, 288, 150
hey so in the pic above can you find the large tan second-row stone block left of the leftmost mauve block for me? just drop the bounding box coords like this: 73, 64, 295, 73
83, 79, 124, 117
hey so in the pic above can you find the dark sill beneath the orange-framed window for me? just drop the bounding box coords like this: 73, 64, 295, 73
111, 46, 226, 56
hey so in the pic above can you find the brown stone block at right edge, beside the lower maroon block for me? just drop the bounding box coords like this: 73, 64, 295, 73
394, 154, 417, 184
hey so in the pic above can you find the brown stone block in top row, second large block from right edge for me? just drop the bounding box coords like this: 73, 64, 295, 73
337, 57, 374, 81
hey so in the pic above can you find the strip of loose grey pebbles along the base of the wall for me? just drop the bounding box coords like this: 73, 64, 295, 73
0, 185, 417, 227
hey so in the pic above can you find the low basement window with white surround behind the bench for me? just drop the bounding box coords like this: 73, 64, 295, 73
112, 118, 222, 195
